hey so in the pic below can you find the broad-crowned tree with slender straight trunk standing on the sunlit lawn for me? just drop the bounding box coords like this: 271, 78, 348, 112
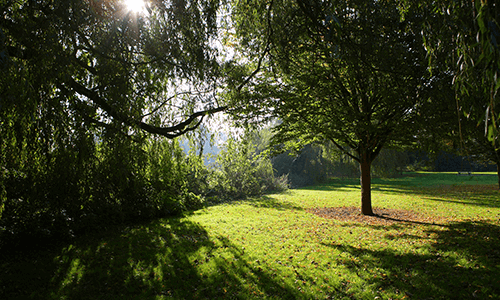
233, 0, 435, 215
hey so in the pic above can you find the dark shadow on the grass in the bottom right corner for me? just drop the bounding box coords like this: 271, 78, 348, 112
325, 222, 500, 299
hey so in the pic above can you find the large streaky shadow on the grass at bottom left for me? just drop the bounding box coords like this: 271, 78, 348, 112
0, 214, 297, 299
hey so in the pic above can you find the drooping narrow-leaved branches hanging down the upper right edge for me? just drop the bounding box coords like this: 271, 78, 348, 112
449, 0, 500, 144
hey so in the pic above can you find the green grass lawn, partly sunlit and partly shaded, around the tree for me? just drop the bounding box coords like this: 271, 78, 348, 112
0, 173, 500, 299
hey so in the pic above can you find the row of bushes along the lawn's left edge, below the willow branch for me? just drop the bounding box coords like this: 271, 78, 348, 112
0, 122, 287, 246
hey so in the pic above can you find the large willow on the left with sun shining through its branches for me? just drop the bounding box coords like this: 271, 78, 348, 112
0, 0, 224, 234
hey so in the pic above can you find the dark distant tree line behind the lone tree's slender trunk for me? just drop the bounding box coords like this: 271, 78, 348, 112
271, 145, 497, 188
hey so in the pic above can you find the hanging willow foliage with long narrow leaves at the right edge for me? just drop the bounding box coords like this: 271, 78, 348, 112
448, 0, 500, 145
